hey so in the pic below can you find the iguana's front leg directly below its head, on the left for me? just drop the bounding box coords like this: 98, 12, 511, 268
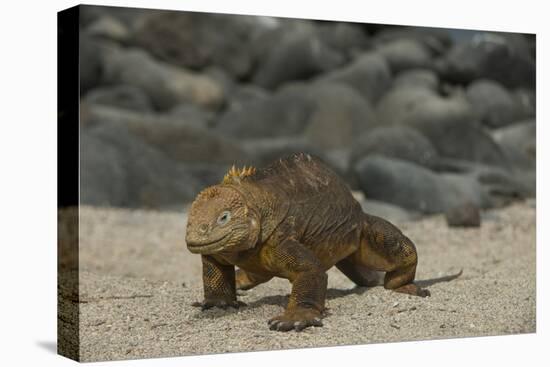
193, 255, 244, 310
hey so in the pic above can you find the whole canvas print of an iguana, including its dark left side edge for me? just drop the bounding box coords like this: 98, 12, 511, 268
57, 5, 536, 361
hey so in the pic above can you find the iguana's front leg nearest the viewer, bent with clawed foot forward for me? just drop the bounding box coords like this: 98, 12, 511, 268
262, 239, 327, 331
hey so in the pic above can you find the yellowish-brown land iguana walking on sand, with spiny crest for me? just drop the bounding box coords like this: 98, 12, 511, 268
186, 153, 430, 331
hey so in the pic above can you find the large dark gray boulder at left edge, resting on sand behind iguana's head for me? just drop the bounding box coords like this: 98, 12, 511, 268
80, 124, 202, 208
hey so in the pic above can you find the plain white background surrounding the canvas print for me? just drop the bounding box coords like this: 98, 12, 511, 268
0, 0, 550, 367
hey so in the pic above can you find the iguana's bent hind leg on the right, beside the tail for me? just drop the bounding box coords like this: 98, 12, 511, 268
351, 215, 430, 297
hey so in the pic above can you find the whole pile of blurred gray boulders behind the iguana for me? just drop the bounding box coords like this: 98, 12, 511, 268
80, 6, 536, 218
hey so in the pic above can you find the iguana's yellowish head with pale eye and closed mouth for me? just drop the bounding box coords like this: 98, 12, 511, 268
185, 184, 260, 255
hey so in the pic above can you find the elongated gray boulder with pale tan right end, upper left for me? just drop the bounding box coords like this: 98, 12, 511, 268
102, 47, 224, 110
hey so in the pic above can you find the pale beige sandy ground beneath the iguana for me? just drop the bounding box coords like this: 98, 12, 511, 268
75, 201, 536, 361
